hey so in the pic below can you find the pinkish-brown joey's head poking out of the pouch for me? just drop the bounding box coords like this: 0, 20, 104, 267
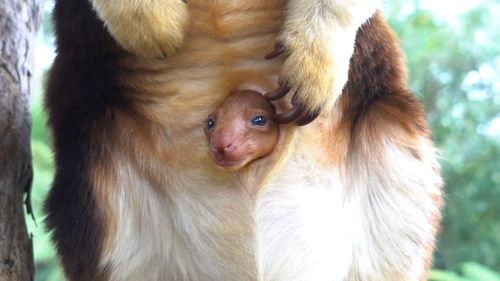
205, 90, 279, 170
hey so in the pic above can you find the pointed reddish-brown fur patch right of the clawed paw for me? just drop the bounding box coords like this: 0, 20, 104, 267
339, 12, 429, 155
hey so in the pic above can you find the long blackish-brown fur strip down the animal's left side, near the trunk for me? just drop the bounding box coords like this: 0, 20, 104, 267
45, 0, 127, 281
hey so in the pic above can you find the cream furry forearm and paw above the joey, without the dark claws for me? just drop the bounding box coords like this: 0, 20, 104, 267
280, 0, 382, 111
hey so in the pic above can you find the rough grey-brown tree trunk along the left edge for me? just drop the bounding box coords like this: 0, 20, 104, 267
0, 0, 41, 281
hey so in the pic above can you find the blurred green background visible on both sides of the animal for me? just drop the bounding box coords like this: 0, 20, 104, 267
27, 0, 500, 281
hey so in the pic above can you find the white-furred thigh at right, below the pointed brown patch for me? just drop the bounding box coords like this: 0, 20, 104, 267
346, 139, 442, 281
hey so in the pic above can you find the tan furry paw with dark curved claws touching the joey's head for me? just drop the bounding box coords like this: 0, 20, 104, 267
265, 32, 354, 126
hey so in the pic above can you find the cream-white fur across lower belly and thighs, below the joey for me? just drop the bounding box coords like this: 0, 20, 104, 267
97, 115, 442, 281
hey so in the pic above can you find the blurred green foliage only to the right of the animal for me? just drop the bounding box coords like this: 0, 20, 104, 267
389, 1, 500, 270
